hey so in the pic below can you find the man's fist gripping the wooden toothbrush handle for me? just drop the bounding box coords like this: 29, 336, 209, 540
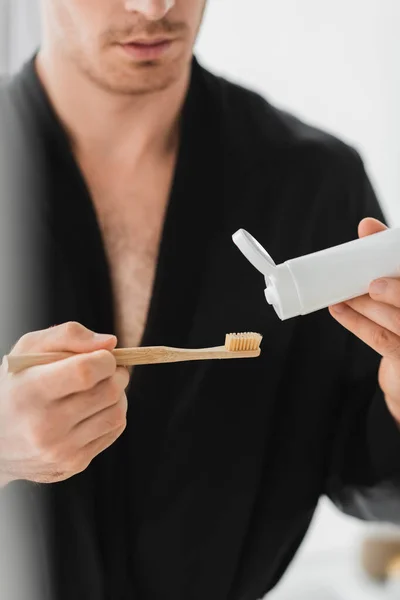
0, 323, 129, 486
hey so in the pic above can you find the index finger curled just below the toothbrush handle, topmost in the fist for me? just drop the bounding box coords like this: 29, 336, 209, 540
18, 350, 116, 402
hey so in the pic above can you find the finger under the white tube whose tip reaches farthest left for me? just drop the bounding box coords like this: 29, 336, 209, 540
329, 304, 400, 359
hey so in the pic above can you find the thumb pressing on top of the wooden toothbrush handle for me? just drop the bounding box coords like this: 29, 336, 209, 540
10, 321, 117, 354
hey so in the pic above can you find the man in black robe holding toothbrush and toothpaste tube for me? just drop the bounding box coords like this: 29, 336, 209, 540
0, 0, 400, 600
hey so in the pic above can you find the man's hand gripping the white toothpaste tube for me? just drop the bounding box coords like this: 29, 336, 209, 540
329, 219, 400, 425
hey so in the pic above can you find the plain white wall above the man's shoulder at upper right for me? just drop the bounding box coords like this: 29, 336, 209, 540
198, 0, 400, 224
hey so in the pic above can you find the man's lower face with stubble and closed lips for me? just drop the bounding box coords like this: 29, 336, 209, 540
42, 0, 207, 94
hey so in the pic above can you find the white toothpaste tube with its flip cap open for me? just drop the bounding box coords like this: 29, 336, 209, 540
233, 228, 400, 320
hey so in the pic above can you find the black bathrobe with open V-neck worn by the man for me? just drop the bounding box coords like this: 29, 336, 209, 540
3, 56, 400, 600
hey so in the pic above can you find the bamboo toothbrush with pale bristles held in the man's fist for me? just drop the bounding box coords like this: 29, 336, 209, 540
3, 332, 262, 373
